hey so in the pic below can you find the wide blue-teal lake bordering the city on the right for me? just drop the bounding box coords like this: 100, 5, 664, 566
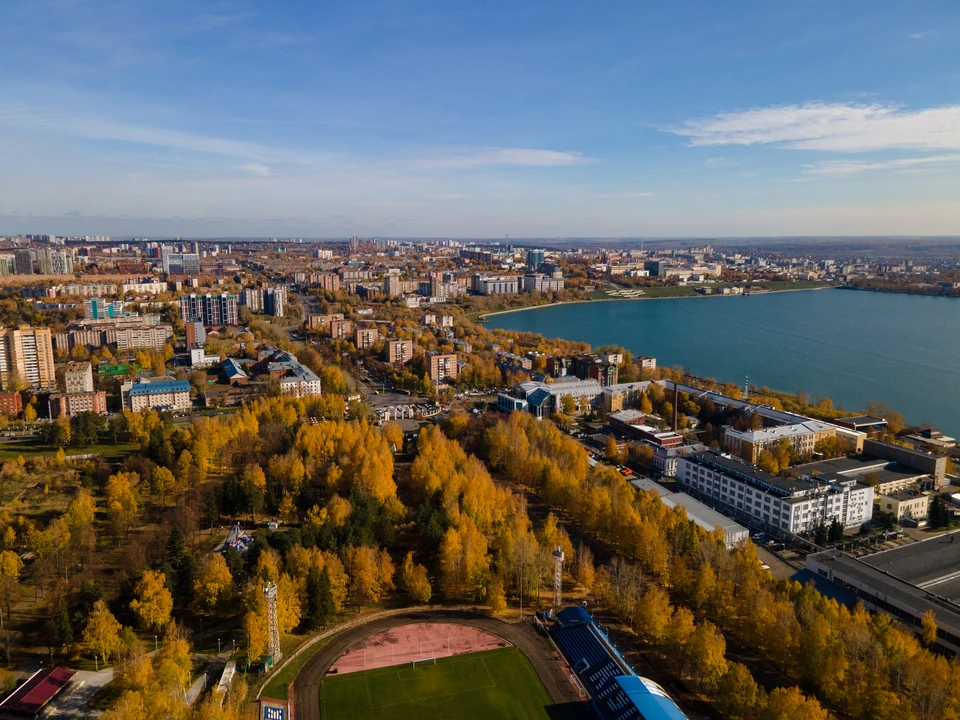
490, 290, 960, 437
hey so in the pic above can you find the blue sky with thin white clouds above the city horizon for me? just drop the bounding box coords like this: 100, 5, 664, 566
0, 0, 960, 238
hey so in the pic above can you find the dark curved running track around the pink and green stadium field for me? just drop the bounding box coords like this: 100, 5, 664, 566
292, 610, 590, 720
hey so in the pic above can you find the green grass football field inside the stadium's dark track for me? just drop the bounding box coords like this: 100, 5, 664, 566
320, 647, 551, 720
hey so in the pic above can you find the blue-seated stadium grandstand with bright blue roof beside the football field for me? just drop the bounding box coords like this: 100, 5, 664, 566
550, 607, 687, 720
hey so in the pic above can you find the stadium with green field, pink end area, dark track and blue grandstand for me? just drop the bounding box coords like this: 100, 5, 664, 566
276, 607, 686, 720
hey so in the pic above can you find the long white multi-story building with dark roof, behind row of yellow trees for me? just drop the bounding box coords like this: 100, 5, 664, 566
677, 452, 873, 535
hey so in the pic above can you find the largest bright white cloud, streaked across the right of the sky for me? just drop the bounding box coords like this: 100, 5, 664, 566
666, 103, 960, 152
